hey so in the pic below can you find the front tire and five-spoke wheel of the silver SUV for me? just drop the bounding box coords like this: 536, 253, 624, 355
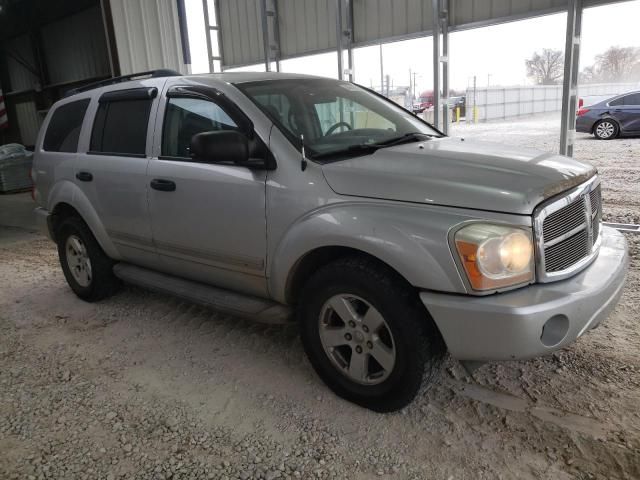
298, 257, 445, 412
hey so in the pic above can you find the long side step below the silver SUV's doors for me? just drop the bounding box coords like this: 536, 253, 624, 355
113, 263, 292, 324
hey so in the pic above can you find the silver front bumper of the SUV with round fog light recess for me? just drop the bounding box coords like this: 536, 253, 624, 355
420, 227, 629, 361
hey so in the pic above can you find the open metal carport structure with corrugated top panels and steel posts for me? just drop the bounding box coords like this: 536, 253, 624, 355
212, 0, 628, 155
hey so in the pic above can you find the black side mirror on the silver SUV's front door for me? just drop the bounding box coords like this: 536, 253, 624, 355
190, 130, 249, 165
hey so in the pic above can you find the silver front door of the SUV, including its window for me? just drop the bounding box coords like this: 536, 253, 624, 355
148, 88, 267, 296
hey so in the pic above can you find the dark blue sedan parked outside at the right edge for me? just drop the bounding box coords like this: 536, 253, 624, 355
576, 92, 640, 140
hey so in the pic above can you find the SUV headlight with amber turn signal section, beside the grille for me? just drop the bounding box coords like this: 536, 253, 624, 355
454, 223, 533, 290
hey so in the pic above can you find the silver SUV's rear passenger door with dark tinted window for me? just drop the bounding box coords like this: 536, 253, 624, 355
75, 79, 166, 268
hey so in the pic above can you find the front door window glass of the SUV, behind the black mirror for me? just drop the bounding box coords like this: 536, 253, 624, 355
162, 98, 238, 158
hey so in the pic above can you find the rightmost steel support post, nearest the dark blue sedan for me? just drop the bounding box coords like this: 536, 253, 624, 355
560, 0, 582, 157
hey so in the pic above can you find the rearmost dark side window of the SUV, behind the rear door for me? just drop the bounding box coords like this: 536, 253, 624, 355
42, 98, 90, 153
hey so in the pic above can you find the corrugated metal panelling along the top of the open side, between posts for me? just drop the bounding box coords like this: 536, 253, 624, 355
219, 0, 619, 66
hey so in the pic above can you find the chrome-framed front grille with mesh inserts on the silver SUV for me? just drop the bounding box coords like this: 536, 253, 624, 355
535, 178, 602, 281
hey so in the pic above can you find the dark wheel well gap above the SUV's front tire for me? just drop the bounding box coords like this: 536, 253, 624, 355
286, 246, 413, 304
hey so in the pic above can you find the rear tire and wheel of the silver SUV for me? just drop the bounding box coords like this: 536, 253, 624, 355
56, 217, 120, 302
